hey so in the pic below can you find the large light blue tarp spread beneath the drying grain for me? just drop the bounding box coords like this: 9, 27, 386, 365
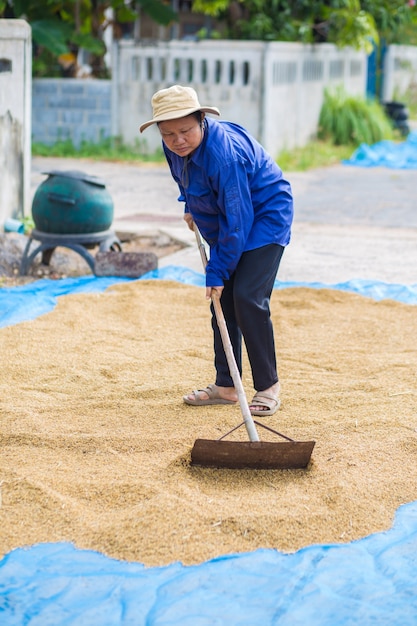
0, 266, 417, 626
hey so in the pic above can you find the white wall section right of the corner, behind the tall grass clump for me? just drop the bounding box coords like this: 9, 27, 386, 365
264, 42, 367, 156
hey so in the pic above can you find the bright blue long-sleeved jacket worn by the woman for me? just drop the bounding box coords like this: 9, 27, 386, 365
163, 118, 293, 287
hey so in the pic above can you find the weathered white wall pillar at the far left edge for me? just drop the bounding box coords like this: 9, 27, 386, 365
0, 19, 32, 225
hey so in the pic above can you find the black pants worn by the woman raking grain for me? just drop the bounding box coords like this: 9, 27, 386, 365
211, 244, 284, 391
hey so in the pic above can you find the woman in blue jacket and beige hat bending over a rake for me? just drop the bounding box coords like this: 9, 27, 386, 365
140, 85, 293, 416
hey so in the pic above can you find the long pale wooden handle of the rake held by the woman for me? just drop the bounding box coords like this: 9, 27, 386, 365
194, 224, 259, 441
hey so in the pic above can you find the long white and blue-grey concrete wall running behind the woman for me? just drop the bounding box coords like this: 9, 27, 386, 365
33, 40, 367, 156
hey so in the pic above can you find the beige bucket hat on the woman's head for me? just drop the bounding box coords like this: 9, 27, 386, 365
139, 85, 220, 133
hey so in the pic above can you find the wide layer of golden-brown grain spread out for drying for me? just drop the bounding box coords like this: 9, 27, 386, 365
0, 280, 417, 566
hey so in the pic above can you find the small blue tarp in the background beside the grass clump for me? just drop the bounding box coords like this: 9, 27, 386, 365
343, 131, 417, 170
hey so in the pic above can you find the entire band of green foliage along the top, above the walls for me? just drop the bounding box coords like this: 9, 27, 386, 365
0, 0, 417, 77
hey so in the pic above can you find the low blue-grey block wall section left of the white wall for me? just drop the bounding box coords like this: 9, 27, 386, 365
32, 78, 112, 146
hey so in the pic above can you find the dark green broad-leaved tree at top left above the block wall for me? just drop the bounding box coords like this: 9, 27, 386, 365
0, 0, 178, 77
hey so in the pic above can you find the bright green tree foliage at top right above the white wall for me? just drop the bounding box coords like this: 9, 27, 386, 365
193, 0, 417, 52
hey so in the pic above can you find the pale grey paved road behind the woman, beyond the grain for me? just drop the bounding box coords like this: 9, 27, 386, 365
32, 157, 417, 284
